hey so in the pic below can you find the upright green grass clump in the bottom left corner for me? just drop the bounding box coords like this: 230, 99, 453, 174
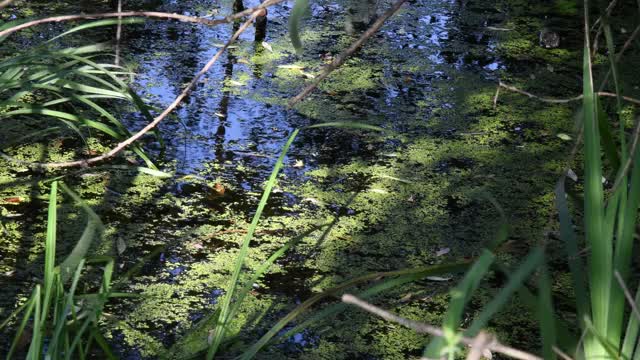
0, 181, 114, 360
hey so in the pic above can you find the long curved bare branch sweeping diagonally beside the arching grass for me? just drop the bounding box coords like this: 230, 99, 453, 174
5, 11, 266, 168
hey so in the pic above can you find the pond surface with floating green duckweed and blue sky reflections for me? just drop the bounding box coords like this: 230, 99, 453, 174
0, 0, 600, 359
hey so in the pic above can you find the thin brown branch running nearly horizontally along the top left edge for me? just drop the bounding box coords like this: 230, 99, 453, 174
0, 0, 284, 37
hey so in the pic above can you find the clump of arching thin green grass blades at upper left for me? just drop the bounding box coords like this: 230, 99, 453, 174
0, 19, 156, 169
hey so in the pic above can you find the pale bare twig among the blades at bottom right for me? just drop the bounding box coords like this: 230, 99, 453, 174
342, 294, 542, 360
